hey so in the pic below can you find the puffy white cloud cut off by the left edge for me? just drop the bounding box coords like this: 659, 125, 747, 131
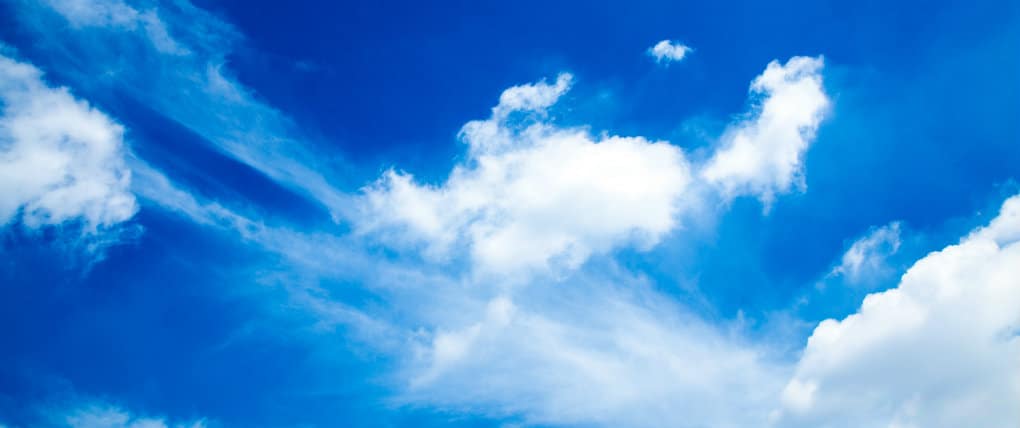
0, 56, 138, 232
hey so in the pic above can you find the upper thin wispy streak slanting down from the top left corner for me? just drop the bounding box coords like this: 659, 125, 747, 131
16, 0, 349, 218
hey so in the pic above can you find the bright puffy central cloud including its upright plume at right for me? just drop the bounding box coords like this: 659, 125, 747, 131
355, 57, 828, 274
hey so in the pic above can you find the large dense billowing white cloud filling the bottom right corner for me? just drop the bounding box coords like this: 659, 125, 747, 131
777, 196, 1020, 428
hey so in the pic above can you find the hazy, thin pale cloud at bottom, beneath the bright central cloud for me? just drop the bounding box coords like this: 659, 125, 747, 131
402, 278, 787, 427
